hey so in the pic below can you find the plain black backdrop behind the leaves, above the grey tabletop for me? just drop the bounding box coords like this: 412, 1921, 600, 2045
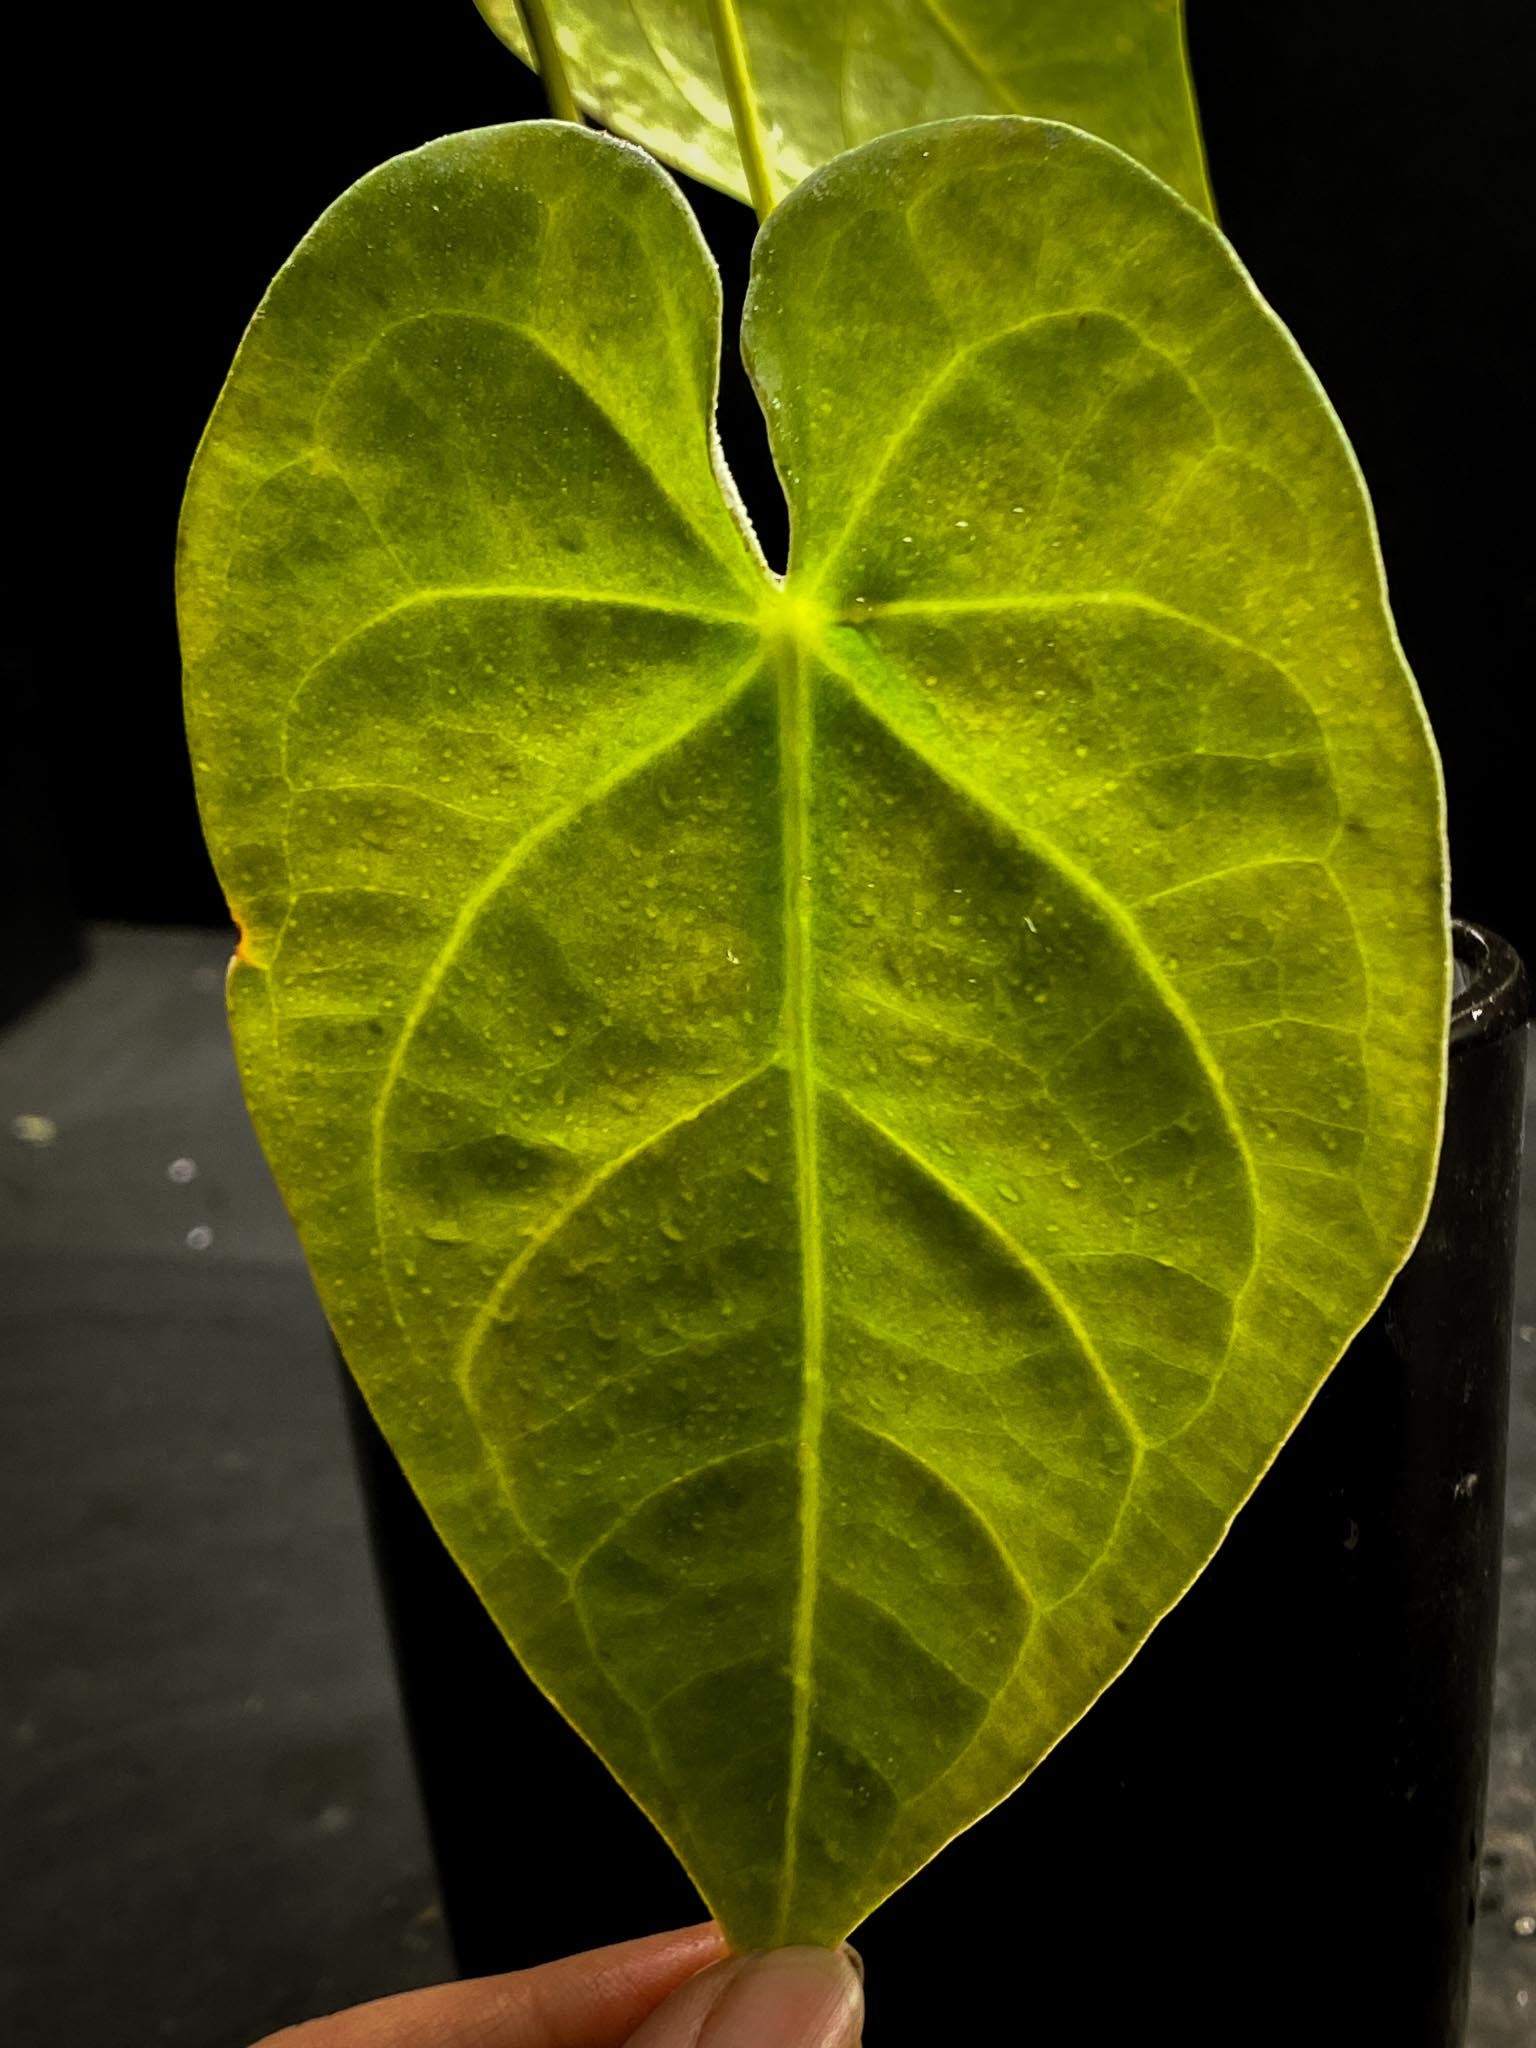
20, 0, 1536, 956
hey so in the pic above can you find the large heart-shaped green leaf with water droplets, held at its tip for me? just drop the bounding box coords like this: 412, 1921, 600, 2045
182, 119, 1448, 1946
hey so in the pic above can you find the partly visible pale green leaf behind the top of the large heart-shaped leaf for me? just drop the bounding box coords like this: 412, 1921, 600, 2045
475, 0, 1210, 213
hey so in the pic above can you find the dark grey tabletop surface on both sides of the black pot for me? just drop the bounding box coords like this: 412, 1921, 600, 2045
0, 928, 1536, 2048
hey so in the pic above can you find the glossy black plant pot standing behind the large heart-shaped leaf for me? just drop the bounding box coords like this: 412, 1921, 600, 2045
348, 924, 1528, 2048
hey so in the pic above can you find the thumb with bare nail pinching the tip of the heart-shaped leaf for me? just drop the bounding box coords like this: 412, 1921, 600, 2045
629, 1948, 864, 2048
